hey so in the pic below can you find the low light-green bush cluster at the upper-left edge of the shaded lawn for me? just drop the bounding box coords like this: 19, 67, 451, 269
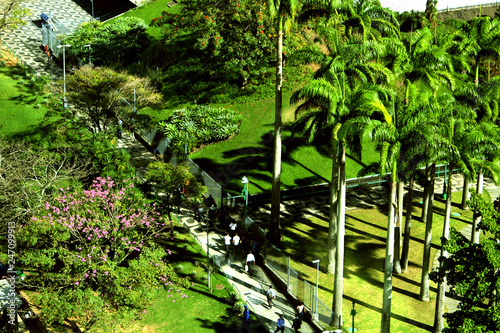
160, 105, 242, 152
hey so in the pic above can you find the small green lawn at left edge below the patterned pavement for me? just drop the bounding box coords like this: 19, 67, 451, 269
0, 67, 47, 139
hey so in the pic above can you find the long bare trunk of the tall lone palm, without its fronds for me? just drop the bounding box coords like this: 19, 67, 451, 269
269, 15, 283, 244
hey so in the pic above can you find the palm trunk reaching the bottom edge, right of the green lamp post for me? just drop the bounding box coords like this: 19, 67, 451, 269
380, 163, 397, 333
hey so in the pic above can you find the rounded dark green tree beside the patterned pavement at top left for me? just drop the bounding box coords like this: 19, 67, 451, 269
63, 17, 150, 66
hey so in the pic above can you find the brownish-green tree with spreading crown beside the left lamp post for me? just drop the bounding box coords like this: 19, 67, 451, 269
45, 66, 161, 135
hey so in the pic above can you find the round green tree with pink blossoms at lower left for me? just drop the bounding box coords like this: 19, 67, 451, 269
16, 177, 186, 328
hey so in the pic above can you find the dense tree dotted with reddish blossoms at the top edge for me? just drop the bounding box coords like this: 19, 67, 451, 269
151, 0, 276, 86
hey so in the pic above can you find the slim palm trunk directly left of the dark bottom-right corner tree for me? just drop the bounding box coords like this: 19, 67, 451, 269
434, 165, 453, 333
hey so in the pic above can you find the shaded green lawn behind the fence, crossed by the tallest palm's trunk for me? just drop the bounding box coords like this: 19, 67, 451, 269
190, 96, 379, 194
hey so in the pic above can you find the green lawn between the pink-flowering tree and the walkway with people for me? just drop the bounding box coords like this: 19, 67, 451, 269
123, 223, 264, 333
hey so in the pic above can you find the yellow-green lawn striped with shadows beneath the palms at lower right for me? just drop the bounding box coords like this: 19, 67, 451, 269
282, 192, 472, 333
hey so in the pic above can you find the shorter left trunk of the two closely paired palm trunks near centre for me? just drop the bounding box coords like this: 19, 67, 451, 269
326, 143, 340, 274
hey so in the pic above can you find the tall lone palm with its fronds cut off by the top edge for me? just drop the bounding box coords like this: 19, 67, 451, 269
268, 0, 299, 243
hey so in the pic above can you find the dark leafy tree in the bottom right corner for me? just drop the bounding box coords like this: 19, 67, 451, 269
431, 191, 500, 333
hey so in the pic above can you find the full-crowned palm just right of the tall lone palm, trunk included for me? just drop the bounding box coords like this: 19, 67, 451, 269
291, 31, 392, 324
